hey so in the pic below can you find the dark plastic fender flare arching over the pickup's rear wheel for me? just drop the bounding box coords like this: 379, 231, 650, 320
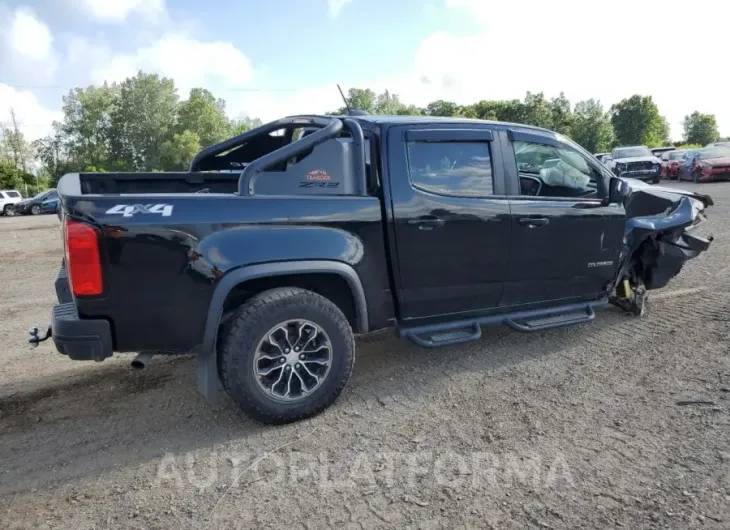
202, 260, 369, 355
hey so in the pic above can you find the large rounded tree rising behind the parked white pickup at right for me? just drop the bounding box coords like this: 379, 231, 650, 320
611, 95, 669, 147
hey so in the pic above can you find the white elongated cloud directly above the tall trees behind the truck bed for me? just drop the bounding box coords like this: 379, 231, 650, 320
91, 33, 253, 96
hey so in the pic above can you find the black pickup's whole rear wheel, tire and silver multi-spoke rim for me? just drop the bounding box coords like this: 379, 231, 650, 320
218, 287, 355, 423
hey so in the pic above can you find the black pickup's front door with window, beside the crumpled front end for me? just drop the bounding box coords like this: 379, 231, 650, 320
501, 127, 625, 307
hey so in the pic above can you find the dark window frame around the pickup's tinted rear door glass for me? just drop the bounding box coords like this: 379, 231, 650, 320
403, 124, 505, 200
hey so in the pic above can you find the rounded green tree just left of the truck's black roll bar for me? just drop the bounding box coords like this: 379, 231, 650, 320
177, 88, 231, 147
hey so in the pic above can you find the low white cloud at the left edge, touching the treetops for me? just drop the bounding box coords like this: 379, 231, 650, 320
0, 83, 63, 141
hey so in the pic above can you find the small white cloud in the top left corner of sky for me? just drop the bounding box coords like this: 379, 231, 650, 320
0, 6, 57, 74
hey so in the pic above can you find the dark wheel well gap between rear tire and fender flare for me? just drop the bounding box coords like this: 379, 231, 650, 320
220, 273, 360, 332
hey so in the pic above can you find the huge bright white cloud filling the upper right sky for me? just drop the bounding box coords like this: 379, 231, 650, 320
438, 0, 730, 139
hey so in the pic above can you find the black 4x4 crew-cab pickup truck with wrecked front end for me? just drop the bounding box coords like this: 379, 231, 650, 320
29, 114, 712, 423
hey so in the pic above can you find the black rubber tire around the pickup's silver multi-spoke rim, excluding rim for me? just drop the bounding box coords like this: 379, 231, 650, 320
218, 287, 355, 424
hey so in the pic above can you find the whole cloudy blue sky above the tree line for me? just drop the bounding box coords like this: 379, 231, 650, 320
0, 0, 730, 139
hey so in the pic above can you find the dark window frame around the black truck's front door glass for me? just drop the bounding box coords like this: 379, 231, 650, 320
503, 129, 612, 204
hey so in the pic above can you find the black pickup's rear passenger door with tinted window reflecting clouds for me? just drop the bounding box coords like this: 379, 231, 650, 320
387, 125, 510, 319
